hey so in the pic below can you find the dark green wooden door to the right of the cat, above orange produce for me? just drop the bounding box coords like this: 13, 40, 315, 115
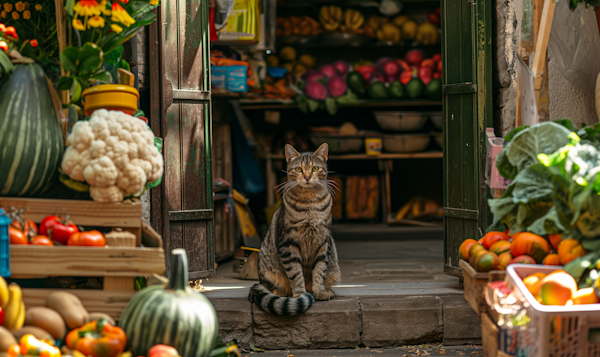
441, 0, 493, 276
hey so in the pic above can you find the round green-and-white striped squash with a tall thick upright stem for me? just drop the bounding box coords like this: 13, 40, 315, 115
119, 249, 219, 357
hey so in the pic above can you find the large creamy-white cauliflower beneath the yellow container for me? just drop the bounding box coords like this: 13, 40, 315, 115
61, 109, 164, 202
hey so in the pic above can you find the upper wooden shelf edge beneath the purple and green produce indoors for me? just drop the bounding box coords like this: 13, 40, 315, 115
240, 99, 442, 110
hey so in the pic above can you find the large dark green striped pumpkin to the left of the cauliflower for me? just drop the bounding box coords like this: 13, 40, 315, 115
0, 64, 63, 196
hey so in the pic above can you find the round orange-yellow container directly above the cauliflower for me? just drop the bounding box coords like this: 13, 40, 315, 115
81, 84, 140, 116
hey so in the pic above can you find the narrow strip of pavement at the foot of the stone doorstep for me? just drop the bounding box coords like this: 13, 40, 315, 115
242, 345, 483, 357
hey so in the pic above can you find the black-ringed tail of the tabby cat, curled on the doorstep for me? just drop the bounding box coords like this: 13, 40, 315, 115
248, 284, 315, 316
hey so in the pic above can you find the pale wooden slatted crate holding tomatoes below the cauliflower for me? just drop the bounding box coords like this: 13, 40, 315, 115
0, 197, 165, 320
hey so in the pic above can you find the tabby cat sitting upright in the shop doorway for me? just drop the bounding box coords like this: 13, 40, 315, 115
248, 144, 341, 316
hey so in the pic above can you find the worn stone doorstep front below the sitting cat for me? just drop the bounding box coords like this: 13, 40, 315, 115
208, 295, 481, 350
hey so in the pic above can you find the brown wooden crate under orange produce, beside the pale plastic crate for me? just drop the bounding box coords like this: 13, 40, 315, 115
459, 260, 506, 315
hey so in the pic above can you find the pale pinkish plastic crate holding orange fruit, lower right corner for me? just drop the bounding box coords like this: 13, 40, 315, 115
506, 264, 600, 357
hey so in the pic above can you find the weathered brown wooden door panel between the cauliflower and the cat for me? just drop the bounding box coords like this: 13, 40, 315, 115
150, 0, 215, 279
